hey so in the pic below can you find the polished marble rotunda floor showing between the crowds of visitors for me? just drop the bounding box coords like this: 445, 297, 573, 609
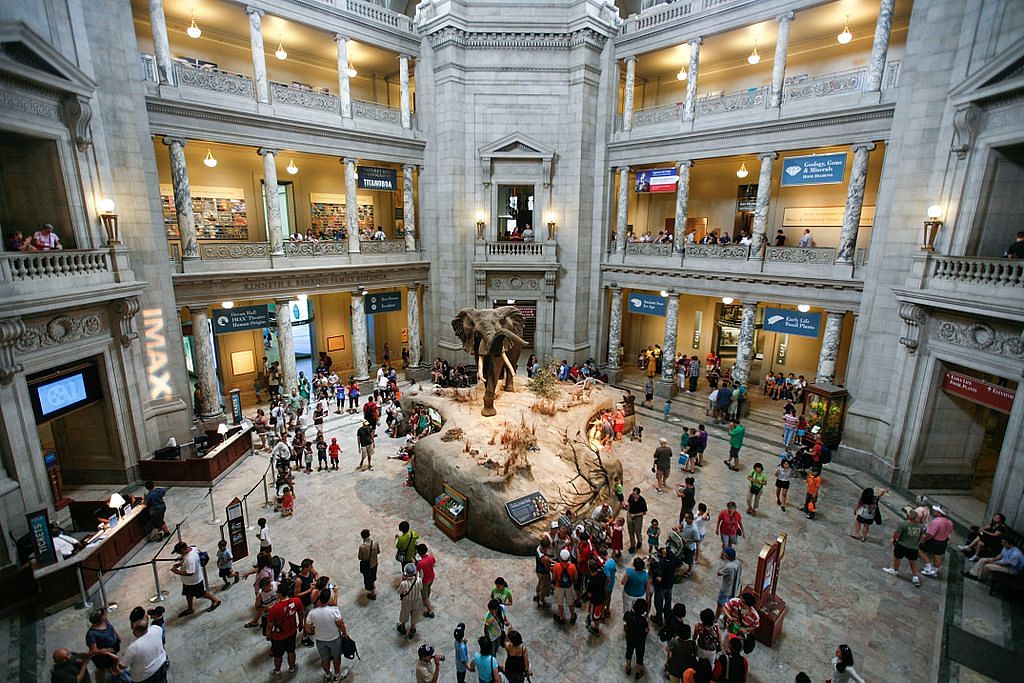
39, 400, 950, 683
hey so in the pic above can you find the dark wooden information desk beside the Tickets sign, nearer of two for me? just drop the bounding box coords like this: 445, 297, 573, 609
33, 501, 150, 613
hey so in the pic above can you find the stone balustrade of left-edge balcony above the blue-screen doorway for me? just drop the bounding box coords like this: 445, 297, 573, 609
0, 249, 134, 298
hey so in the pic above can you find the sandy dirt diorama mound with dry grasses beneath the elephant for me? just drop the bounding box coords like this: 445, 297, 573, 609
403, 377, 623, 555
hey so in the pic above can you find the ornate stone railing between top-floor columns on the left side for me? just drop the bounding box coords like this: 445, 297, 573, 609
141, 56, 407, 129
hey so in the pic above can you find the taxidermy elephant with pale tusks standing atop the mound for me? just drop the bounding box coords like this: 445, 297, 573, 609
452, 306, 526, 418
